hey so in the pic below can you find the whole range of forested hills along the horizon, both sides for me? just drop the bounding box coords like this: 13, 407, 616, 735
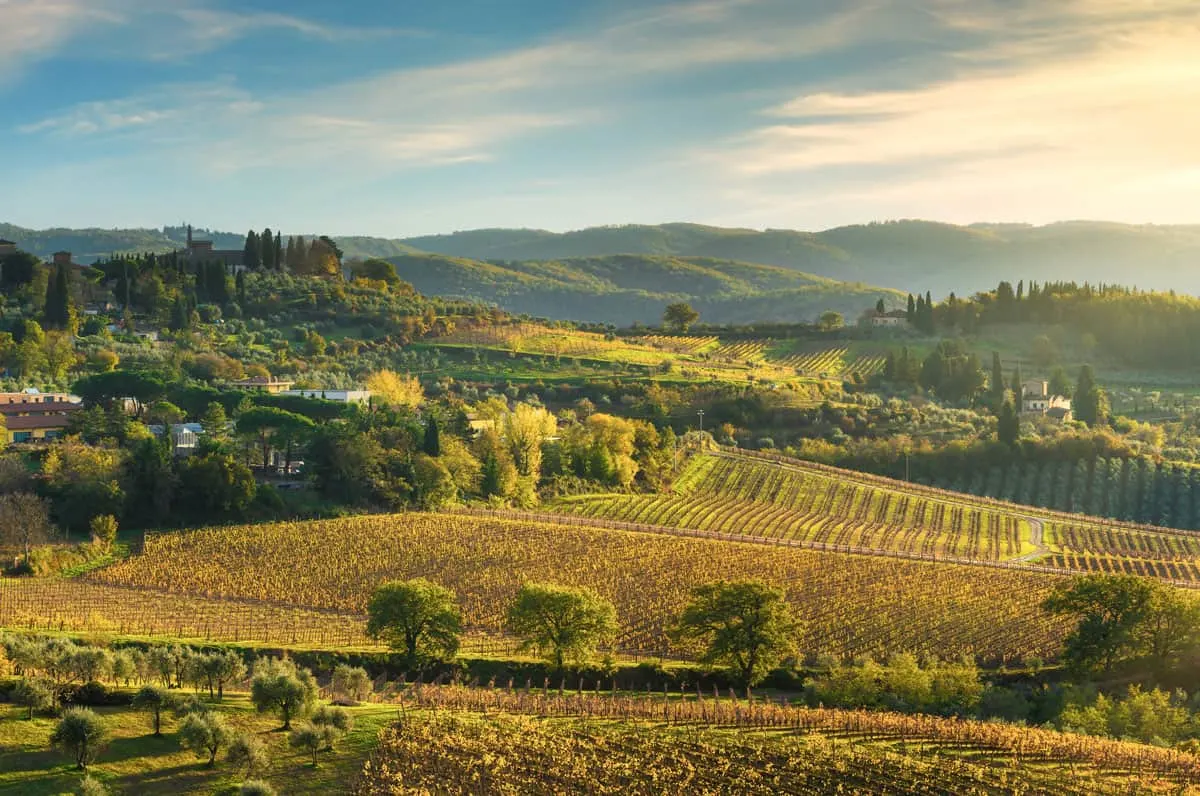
0, 221, 1200, 322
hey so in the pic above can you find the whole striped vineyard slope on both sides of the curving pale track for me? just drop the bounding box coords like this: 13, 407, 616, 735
554, 454, 1200, 586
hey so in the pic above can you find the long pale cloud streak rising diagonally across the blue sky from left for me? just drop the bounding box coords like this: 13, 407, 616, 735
14, 0, 888, 172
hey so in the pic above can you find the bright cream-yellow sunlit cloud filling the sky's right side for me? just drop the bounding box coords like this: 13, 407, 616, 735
697, 0, 1200, 224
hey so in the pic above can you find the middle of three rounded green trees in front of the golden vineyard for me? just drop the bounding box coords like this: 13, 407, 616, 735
508, 583, 617, 671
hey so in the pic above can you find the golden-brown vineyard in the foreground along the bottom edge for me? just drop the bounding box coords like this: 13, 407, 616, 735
356, 683, 1200, 796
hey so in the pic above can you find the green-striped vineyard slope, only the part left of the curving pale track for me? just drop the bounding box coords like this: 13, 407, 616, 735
556, 456, 1037, 561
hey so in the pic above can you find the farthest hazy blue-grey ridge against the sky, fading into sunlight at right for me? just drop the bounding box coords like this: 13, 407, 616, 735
403, 221, 1200, 297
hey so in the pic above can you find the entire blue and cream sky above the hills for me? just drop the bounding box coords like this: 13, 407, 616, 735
0, 0, 1200, 237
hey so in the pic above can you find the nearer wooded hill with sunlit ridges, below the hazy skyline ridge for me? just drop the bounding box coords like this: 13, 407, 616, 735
391, 253, 905, 325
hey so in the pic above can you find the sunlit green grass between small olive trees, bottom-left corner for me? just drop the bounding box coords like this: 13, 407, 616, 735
0, 694, 396, 796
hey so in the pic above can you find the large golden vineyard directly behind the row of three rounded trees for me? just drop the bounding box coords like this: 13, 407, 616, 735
21, 514, 1067, 663
